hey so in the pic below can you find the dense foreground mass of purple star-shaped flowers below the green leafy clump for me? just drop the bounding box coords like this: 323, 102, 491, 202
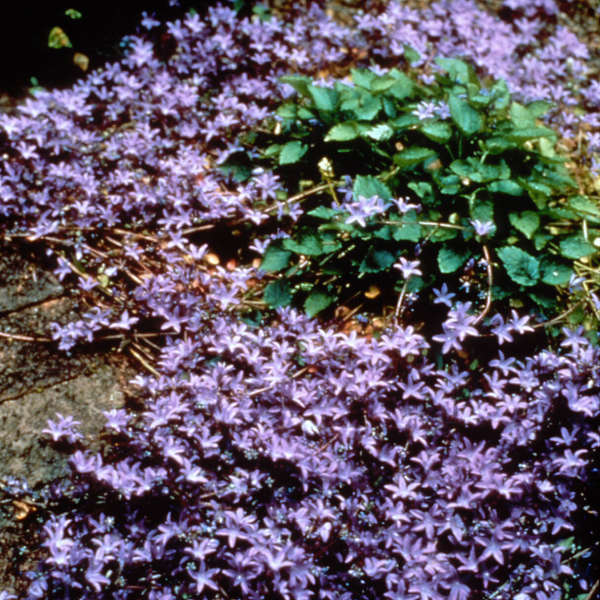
21, 298, 600, 600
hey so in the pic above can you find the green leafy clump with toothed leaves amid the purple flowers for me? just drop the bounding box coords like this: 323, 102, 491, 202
240, 58, 600, 318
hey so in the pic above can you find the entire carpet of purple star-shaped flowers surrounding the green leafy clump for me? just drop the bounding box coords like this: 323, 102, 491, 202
0, 0, 600, 600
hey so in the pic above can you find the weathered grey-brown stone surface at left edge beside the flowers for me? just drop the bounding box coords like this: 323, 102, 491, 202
0, 246, 133, 592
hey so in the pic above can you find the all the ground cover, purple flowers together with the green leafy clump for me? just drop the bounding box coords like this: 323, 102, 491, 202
0, 1, 600, 600
